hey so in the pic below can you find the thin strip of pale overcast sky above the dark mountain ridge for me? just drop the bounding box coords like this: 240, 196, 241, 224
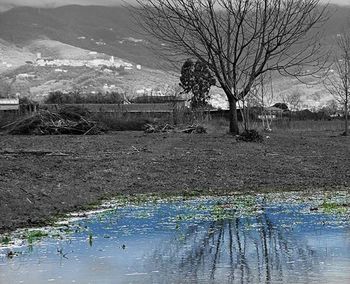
0, 0, 350, 9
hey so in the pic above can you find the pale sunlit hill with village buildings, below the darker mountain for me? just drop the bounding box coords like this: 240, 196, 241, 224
0, 39, 178, 101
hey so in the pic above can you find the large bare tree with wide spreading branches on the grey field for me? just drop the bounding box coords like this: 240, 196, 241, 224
133, 0, 326, 134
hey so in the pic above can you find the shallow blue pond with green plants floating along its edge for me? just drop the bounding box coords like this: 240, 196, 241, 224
0, 192, 350, 284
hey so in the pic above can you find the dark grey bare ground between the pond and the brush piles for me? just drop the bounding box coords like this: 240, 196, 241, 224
0, 131, 350, 232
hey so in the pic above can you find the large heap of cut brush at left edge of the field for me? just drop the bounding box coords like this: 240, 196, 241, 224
8, 107, 103, 135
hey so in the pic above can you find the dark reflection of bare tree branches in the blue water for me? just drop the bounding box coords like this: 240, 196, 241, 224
149, 205, 326, 283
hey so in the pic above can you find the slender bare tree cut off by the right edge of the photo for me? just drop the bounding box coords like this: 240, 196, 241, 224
324, 33, 350, 136
